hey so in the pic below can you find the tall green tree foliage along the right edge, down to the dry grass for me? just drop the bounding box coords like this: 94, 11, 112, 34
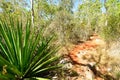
101, 0, 120, 41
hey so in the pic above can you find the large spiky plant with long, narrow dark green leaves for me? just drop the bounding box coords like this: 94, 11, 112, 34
0, 18, 61, 80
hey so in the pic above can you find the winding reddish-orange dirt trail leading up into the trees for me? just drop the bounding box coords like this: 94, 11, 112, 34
60, 34, 115, 80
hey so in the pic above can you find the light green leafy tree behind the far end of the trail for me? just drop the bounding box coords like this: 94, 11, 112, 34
72, 0, 101, 40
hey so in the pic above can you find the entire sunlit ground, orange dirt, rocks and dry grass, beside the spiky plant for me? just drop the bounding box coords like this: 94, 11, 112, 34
53, 34, 120, 80
